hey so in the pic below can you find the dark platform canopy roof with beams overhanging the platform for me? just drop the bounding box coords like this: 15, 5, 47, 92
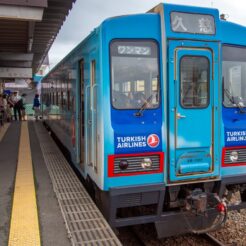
0, 0, 76, 79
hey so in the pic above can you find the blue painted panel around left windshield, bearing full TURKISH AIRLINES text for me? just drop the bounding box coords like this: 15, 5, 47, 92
100, 14, 166, 190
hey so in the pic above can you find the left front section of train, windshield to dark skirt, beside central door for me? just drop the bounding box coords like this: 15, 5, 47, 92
102, 13, 166, 227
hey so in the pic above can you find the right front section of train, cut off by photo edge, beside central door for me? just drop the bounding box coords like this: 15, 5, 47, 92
221, 20, 246, 213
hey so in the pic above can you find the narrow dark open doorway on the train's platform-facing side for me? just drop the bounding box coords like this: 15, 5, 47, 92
79, 59, 85, 171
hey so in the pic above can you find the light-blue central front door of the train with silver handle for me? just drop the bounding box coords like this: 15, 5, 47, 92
168, 41, 219, 182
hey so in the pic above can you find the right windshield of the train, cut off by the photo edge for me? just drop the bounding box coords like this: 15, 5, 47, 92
223, 46, 246, 108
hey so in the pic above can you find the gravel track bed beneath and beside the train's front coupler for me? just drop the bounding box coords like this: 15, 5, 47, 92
119, 209, 246, 246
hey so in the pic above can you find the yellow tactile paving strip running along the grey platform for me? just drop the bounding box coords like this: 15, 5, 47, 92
8, 122, 41, 246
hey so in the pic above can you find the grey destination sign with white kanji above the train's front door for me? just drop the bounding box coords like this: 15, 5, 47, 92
171, 12, 215, 35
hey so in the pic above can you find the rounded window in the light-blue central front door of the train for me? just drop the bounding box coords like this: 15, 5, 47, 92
180, 56, 209, 108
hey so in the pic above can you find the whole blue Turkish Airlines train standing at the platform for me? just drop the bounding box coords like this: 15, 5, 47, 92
42, 4, 246, 237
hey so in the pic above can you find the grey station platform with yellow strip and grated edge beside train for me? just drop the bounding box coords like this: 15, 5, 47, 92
0, 121, 121, 246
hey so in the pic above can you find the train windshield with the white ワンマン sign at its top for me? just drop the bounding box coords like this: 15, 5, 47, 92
110, 40, 160, 109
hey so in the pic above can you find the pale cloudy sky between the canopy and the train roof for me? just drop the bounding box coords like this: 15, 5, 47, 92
49, 0, 246, 68
